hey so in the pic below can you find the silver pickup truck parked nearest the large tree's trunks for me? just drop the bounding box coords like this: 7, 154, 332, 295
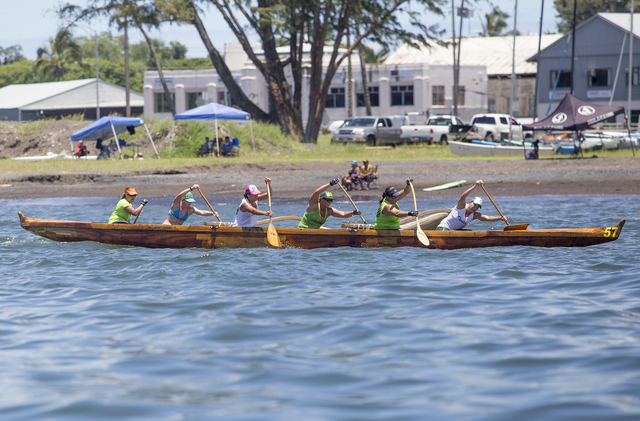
331, 115, 409, 146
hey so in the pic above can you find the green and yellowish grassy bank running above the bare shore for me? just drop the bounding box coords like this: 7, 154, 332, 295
0, 120, 640, 174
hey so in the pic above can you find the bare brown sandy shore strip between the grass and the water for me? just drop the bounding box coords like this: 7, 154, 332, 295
0, 157, 640, 200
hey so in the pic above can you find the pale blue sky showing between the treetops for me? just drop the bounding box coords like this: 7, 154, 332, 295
0, 0, 557, 59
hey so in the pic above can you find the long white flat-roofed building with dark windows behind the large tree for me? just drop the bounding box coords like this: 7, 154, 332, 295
144, 44, 487, 124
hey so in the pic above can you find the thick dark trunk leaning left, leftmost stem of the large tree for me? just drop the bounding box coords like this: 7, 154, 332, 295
191, 3, 273, 122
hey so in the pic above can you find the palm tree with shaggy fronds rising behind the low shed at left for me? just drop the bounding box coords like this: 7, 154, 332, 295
33, 29, 89, 81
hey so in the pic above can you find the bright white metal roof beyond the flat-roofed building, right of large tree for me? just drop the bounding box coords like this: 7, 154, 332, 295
384, 34, 562, 76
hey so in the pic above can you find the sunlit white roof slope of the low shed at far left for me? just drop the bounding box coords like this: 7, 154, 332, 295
0, 79, 95, 109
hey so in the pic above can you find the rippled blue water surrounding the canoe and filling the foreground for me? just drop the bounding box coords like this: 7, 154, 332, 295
0, 196, 640, 421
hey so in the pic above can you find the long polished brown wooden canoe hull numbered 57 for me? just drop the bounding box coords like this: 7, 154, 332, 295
18, 212, 625, 250
